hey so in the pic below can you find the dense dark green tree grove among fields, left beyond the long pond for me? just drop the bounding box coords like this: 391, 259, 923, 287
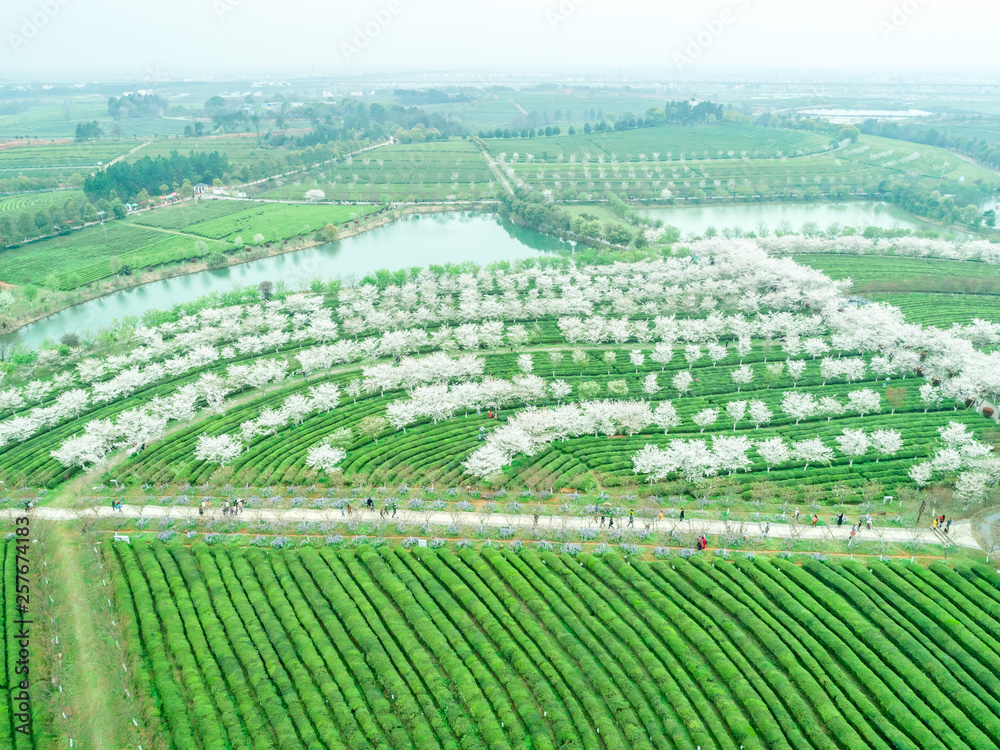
83, 151, 230, 202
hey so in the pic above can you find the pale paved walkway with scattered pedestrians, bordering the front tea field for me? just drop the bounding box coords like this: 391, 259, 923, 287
0, 505, 980, 549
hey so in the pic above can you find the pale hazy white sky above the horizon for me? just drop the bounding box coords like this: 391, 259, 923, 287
0, 0, 1000, 80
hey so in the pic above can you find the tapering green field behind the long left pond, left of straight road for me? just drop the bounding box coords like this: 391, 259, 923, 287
263, 141, 498, 201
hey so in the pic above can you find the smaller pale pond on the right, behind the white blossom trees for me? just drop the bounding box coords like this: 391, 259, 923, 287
639, 201, 968, 238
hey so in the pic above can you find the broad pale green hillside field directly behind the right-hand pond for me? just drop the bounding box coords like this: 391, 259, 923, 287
487, 131, 1000, 201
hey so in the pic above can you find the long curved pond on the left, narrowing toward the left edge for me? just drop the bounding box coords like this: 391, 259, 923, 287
5, 212, 567, 347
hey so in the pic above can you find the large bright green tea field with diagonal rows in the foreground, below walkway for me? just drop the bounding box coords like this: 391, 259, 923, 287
103, 542, 1000, 750
